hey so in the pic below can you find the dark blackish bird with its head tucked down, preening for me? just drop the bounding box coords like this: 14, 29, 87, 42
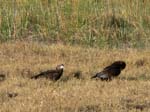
91, 61, 126, 80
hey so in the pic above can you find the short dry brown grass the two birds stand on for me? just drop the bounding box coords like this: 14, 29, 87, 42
0, 41, 150, 112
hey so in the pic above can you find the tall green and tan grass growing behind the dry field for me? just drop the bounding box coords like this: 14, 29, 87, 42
0, 0, 150, 48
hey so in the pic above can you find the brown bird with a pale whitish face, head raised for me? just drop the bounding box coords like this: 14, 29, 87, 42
31, 64, 64, 81
